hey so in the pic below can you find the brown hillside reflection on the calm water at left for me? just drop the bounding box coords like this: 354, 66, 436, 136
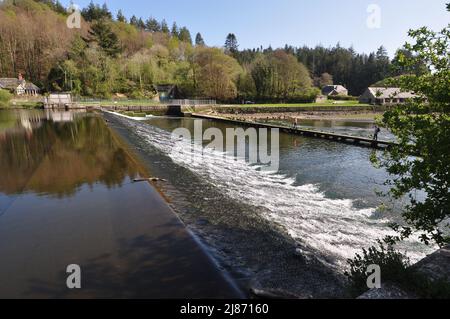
0, 111, 138, 197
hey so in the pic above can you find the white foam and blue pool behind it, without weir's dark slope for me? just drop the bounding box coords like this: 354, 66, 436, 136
109, 117, 429, 268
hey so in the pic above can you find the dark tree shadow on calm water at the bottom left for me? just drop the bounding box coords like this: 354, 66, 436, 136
25, 224, 235, 299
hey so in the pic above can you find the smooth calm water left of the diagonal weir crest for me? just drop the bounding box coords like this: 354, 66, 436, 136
0, 111, 238, 298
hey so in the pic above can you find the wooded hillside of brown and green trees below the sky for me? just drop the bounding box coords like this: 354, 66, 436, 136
0, 0, 421, 102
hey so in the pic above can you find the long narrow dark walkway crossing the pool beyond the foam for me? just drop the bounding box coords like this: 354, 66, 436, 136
191, 113, 397, 149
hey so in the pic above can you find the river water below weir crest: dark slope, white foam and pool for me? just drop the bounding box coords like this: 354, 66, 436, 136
104, 115, 432, 296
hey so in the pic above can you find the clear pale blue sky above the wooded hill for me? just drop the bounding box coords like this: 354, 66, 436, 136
63, 0, 450, 55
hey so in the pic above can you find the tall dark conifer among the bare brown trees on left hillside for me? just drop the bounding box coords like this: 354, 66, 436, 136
86, 19, 121, 57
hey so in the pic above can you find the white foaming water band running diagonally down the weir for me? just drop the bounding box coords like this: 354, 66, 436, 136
118, 115, 432, 268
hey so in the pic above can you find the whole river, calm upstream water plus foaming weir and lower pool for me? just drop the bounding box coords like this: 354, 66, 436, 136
0, 111, 432, 298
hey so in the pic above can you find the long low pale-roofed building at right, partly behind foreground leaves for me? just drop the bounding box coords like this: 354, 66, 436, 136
359, 87, 417, 105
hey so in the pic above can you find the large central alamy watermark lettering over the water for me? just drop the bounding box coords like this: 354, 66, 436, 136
171, 120, 280, 172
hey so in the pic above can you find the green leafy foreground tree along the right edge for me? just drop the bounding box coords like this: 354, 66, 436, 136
373, 25, 450, 246
